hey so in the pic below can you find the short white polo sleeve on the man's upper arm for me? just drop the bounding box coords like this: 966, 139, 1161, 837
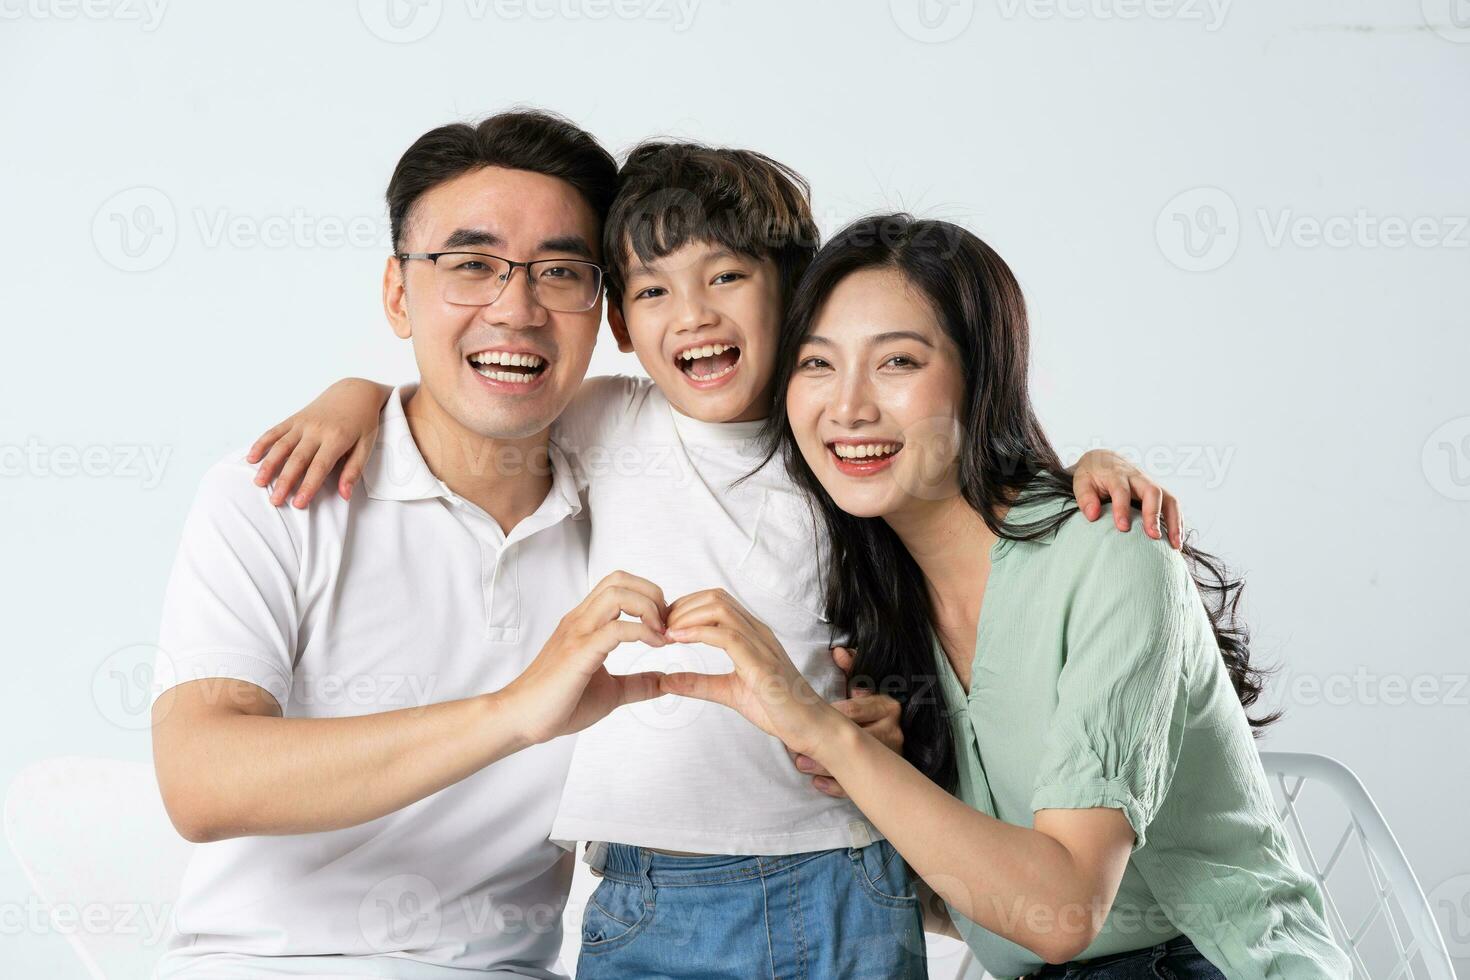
150, 457, 301, 717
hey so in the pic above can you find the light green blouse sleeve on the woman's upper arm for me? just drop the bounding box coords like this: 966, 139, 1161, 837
1032, 525, 1198, 851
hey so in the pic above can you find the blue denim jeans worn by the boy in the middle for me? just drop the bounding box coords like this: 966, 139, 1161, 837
576, 840, 928, 980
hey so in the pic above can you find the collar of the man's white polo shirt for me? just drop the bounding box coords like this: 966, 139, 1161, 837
363, 383, 582, 523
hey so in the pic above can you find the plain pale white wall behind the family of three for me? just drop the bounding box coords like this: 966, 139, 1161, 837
0, 0, 1470, 977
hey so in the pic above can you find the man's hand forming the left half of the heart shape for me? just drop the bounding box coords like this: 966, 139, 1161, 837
500, 572, 667, 745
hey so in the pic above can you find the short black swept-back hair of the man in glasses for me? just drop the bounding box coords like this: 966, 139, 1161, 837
388, 110, 617, 251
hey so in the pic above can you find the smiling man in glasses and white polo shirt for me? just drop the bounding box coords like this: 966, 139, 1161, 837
143, 113, 666, 980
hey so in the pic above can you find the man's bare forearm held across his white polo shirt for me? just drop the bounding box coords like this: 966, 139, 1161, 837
154, 681, 526, 842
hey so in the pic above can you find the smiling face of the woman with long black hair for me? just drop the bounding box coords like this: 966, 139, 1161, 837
786, 267, 964, 517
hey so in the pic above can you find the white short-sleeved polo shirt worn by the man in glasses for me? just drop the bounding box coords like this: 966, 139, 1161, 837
153, 385, 588, 980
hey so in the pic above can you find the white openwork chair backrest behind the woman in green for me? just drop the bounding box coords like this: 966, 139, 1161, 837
1261, 752, 1455, 980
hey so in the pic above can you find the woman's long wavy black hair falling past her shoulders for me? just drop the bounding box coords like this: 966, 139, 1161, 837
766, 213, 1277, 789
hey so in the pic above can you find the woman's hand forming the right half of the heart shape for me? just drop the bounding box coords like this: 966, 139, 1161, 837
662, 589, 851, 758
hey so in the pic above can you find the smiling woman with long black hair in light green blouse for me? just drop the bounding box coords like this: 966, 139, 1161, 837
663, 215, 1348, 980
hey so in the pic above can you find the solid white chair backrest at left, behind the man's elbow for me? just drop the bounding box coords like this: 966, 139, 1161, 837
4, 755, 191, 980
